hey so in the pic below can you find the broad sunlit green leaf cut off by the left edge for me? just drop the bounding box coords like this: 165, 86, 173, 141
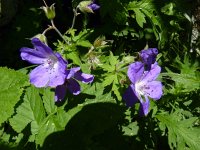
0, 67, 29, 124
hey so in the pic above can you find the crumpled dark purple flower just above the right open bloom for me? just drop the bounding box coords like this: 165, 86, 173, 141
139, 48, 158, 71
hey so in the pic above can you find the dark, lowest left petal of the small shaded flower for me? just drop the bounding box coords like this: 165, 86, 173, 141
55, 84, 67, 101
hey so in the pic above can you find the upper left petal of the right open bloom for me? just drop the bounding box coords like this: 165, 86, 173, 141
127, 62, 144, 83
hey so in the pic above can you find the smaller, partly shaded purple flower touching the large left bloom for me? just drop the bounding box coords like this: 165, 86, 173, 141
55, 67, 94, 101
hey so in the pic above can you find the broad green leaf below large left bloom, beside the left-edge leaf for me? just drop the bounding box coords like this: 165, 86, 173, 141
9, 86, 45, 135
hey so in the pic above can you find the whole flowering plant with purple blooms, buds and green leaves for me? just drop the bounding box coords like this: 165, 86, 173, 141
0, 0, 200, 150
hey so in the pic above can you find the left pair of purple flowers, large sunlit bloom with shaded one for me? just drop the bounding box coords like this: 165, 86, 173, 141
20, 38, 94, 101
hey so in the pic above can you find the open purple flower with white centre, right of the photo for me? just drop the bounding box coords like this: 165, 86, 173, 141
123, 62, 163, 115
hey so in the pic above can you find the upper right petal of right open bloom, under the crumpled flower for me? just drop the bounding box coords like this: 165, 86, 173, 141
142, 62, 161, 82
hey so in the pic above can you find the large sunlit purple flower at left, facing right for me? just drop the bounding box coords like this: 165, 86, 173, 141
20, 38, 67, 87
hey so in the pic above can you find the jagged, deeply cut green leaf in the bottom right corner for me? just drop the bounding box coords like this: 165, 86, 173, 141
156, 111, 200, 150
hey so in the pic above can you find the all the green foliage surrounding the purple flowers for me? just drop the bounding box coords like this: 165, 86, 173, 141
0, 0, 200, 150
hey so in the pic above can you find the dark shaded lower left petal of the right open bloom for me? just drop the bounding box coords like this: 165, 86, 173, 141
123, 84, 139, 107
